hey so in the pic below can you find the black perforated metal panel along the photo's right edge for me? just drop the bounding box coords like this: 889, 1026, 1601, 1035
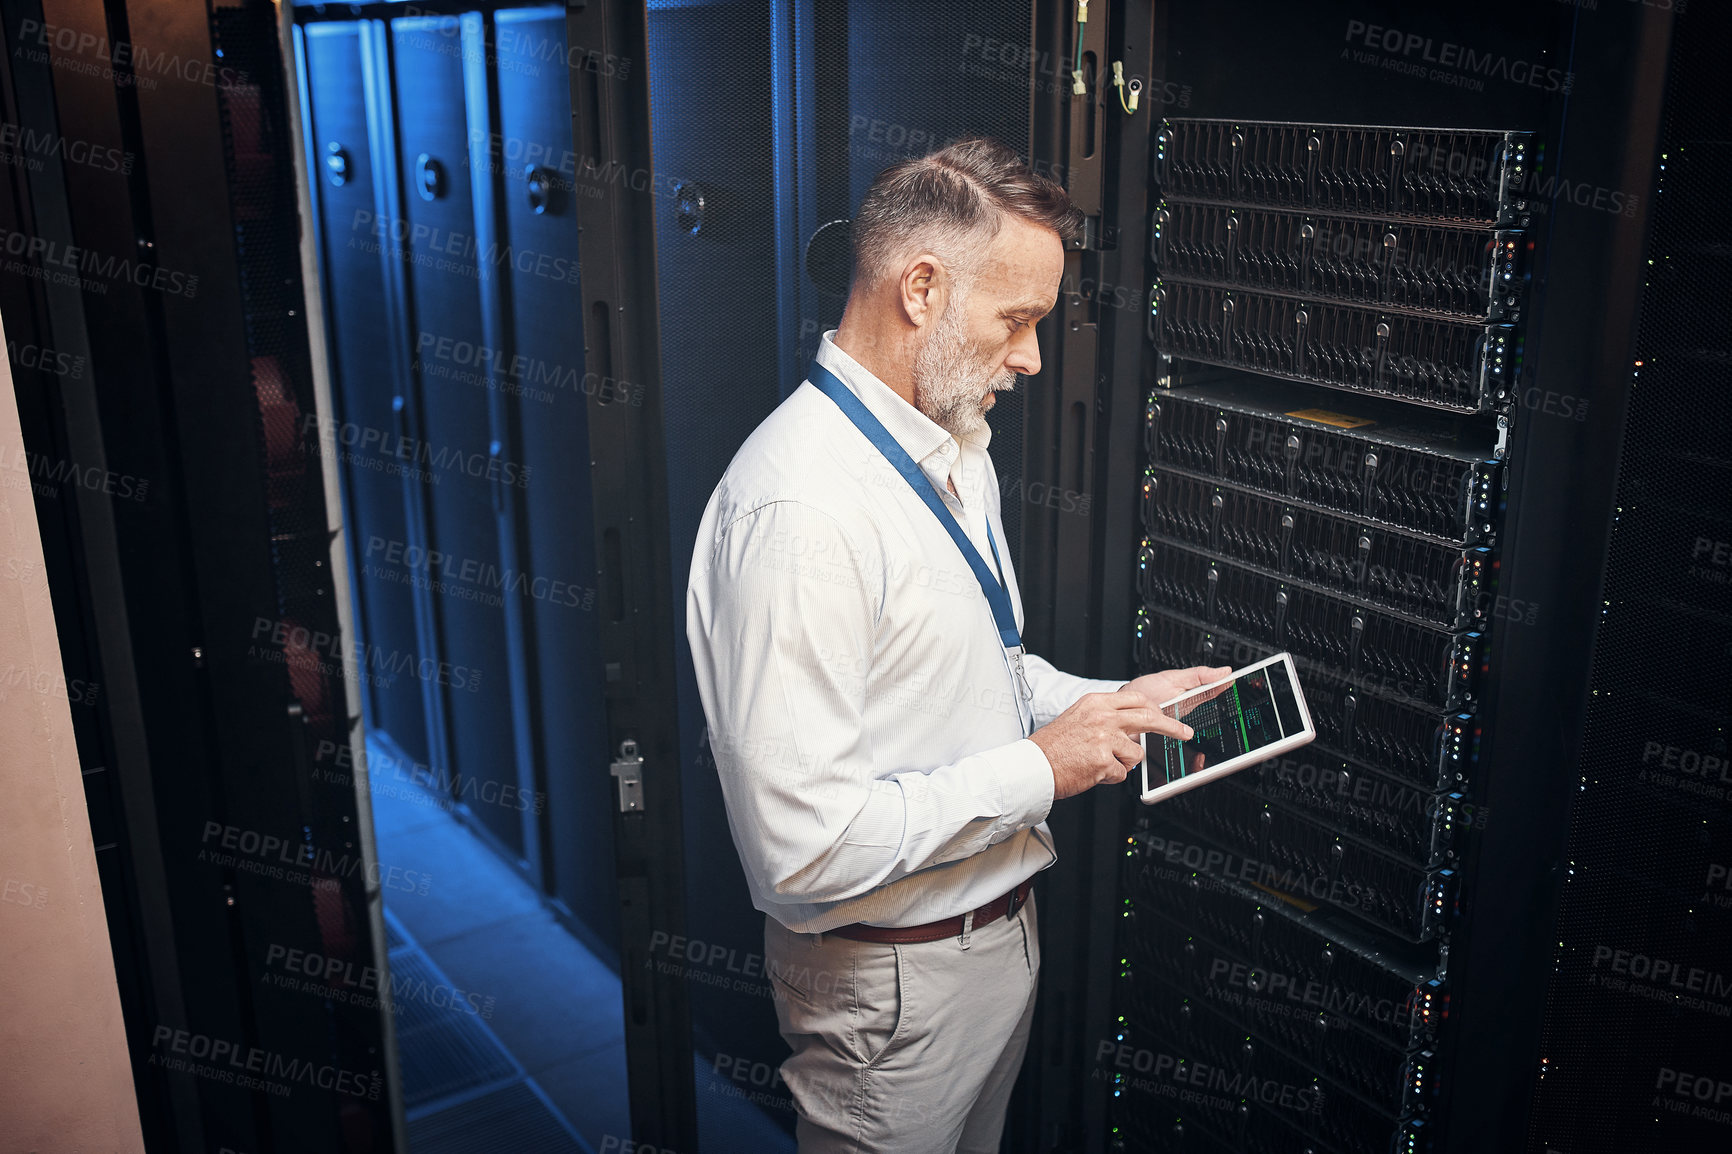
1526, 5, 1732, 1154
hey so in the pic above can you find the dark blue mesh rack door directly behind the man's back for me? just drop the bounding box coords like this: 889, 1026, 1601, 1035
646, 0, 797, 1129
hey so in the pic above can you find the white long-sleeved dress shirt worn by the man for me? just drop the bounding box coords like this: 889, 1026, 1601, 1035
686, 333, 1122, 932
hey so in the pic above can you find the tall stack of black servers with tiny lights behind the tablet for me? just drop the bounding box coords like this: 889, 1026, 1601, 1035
1096, 118, 1535, 1154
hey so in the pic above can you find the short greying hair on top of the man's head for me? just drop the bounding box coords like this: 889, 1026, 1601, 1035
850, 137, 1083, 284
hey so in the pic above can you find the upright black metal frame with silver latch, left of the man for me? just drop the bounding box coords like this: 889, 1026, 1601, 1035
566, 3, 698, 1151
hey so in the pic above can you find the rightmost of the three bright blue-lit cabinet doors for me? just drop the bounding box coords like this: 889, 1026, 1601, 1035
491, 7, 620, 951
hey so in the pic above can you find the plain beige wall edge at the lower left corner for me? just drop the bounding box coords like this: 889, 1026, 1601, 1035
0, 317, 144, 1154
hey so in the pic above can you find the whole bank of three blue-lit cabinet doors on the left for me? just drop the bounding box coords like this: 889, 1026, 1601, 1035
296, 5, 616, 956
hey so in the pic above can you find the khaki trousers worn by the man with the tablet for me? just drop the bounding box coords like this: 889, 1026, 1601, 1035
764, 883, 1041, 1154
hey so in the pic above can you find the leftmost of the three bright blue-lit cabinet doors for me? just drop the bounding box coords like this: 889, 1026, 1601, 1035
303, 21, 430, 764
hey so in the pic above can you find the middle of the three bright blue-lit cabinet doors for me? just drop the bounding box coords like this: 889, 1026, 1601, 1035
393, 14, 525, 856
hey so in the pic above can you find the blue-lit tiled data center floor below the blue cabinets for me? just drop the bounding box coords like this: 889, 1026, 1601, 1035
369, 742, 793, 1154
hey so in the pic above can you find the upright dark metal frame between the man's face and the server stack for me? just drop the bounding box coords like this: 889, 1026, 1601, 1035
1011, 0, 1164, 1151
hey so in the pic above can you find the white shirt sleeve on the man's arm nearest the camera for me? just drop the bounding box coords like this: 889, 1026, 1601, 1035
686, 501, 1053, 904
